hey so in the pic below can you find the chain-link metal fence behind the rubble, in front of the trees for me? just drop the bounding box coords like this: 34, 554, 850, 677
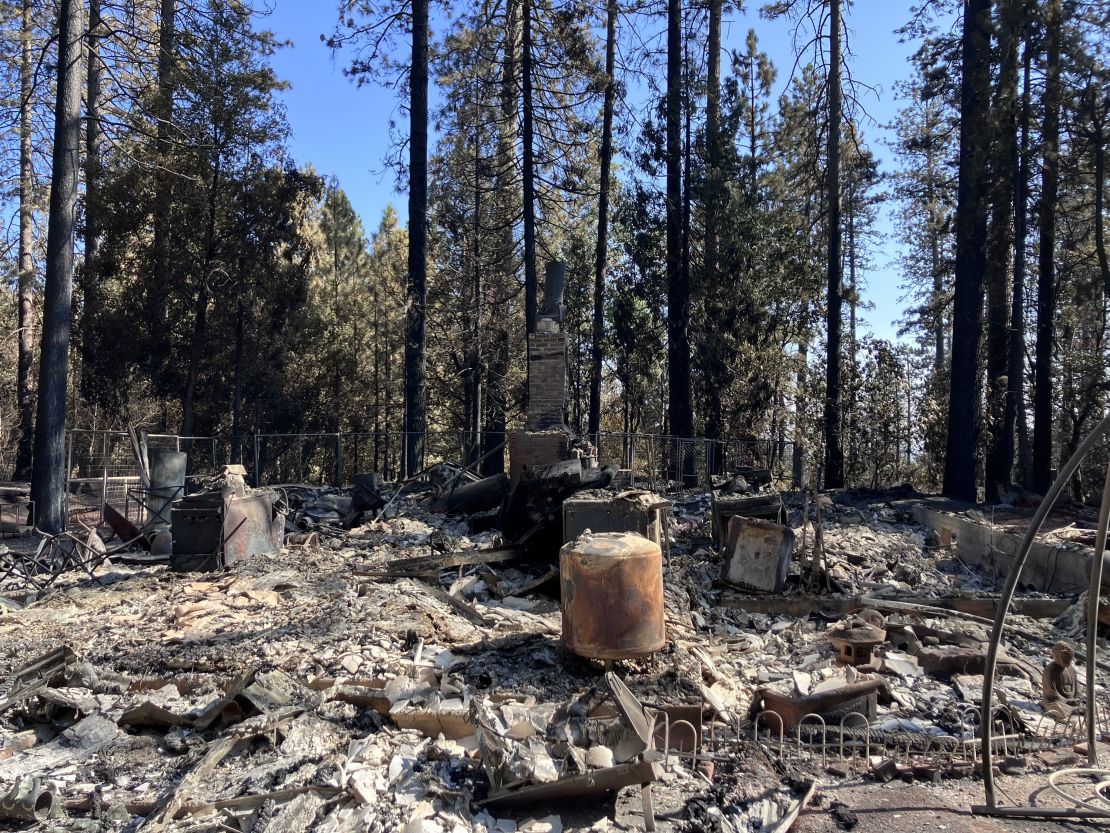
65, 429, 793, 522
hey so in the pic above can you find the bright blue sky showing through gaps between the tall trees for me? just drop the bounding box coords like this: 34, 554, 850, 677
264, 0, 954, 338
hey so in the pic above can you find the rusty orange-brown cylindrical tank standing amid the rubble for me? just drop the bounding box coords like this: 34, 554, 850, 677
558, 532, 666, 660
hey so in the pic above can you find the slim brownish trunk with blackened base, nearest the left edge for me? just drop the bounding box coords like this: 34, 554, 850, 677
14, 0, 34, 480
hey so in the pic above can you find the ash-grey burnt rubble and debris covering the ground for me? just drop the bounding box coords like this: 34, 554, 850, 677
0, 486, 1106, 833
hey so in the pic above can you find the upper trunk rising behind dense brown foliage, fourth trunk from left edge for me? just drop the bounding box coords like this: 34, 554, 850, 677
149, 0, 176, 392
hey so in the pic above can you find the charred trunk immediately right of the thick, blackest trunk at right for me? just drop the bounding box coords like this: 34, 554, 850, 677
983, 0, 1025, 501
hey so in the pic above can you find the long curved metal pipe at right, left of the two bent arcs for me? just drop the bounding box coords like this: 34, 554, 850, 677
981, 413, 1110, 811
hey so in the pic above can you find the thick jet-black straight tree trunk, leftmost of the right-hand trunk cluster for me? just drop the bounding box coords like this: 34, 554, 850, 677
944, 0, 991, 501
